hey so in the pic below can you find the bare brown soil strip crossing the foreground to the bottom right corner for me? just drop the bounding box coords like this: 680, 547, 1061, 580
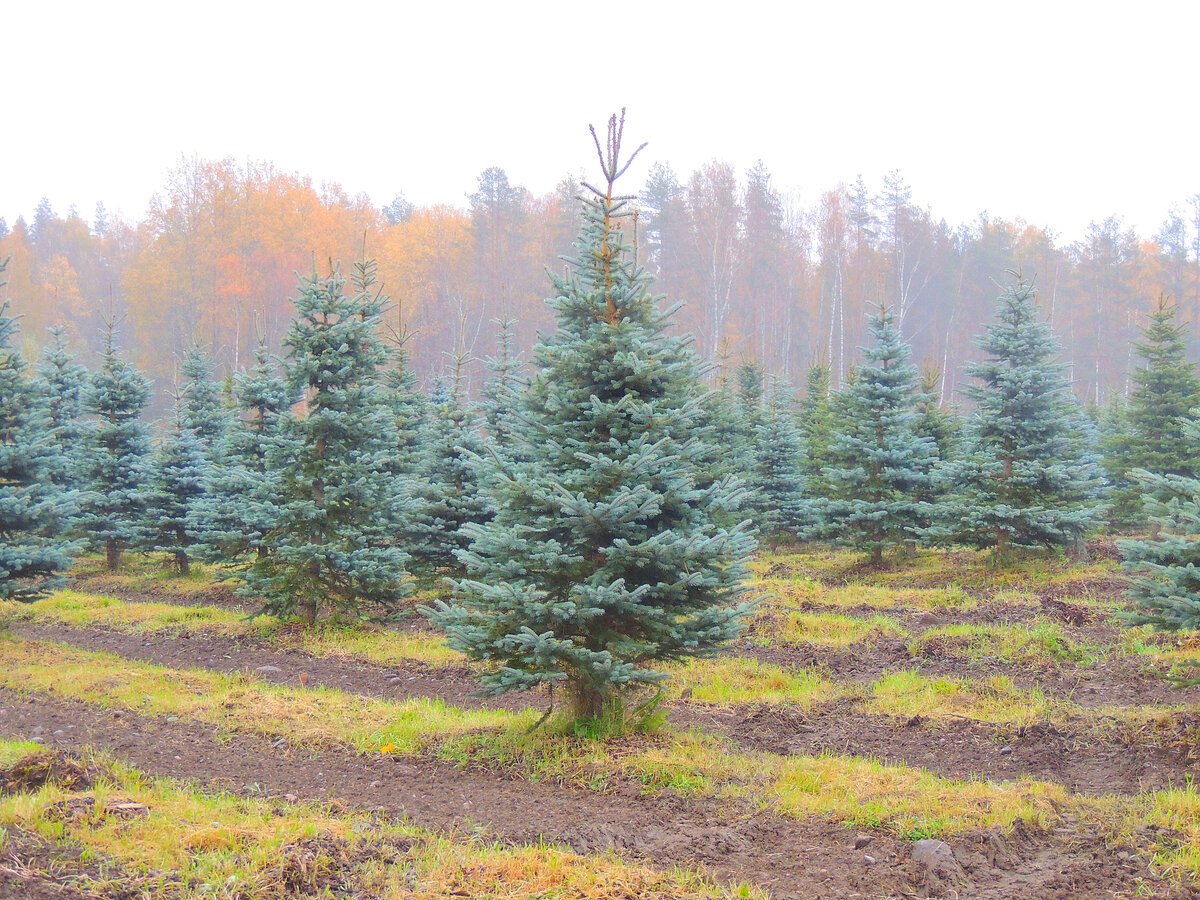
0, 691, 1189, 900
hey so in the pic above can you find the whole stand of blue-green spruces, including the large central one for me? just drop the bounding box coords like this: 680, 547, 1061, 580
7, 116, 1200, 718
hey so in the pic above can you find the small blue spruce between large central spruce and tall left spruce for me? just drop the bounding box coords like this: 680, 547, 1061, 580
403, 356, 494, 575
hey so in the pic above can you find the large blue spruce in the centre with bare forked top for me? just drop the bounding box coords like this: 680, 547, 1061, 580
427, 116, 754, 718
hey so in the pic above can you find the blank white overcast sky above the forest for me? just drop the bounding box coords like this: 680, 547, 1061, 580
0, 0, 1200, 239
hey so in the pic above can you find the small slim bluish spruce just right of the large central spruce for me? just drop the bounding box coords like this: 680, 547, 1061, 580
750, 379, 806, 542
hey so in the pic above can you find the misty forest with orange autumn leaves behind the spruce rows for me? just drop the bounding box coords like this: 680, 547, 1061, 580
0, 160, 1200, 404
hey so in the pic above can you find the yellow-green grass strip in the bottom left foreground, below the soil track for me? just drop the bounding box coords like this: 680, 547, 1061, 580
0, 742, 764, 900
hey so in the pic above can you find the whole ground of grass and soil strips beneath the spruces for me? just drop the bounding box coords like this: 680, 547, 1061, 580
0, 545, 1200, 898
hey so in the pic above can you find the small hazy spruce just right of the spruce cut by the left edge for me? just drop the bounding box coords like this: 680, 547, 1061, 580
36, 328, 88, 491
